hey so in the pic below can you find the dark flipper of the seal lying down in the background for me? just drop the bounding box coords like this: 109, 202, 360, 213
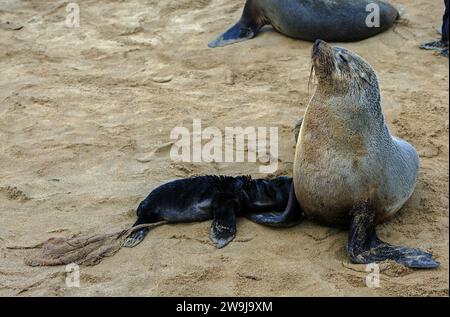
208, 0, 265, 48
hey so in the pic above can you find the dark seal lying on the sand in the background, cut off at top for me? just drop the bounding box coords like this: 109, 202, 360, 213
208, 0, 399, 47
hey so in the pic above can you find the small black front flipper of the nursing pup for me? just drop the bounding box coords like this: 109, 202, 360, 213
211, 199, 236, 249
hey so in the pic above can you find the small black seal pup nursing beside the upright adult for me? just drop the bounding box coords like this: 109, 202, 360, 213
123, 176, 292, 248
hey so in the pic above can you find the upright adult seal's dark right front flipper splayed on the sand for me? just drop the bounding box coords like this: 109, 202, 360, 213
348, 203, 439, 268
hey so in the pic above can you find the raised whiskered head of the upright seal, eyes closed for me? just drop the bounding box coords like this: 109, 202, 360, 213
311, 40, 379, 95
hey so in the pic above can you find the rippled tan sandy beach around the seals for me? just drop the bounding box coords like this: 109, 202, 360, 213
0, 0, 449, 296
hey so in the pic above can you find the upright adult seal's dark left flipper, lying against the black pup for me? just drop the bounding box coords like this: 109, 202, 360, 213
246, 184, 303, 228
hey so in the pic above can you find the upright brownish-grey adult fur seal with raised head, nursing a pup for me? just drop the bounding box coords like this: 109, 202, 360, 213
252, 40, 439, 268
